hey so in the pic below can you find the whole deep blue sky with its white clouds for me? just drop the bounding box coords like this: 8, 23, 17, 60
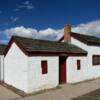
0, 0, 100, 43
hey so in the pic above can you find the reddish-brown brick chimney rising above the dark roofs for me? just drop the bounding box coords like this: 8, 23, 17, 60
64, 25, 71, 43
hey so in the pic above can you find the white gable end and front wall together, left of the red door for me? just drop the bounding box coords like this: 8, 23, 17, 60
4, 43, 59, 93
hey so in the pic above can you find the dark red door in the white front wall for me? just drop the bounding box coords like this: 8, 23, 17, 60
59, 57, 66, 84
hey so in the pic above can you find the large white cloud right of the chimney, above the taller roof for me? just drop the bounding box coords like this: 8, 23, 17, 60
72, 20, 100, 36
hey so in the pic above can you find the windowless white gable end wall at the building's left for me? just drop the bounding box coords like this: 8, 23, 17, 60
4, 43, 28, 91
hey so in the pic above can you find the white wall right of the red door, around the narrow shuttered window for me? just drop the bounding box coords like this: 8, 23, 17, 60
66, 56, 88, 83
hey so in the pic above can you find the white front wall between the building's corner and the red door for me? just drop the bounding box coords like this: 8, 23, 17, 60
27, 56, 59, 92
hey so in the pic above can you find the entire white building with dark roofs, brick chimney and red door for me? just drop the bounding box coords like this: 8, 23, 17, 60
3, 25, 100, 93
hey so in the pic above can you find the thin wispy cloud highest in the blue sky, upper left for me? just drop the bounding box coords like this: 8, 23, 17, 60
13, 1, 34, 12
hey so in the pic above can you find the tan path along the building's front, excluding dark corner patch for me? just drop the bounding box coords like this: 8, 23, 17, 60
18, 79, 100, 100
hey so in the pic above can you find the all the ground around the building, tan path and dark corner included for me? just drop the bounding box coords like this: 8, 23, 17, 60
0, 79, 100, 100
